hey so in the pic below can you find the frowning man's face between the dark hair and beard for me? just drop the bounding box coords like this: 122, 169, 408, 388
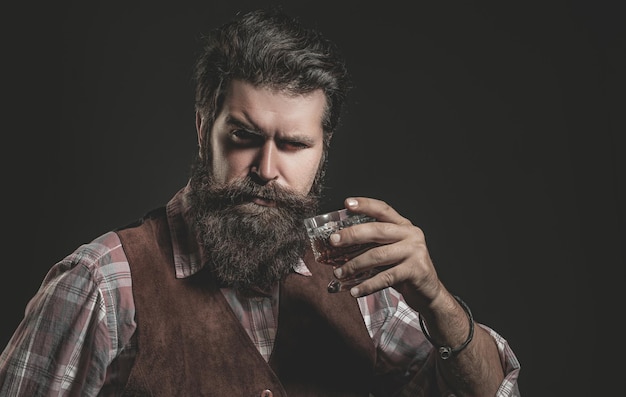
196, 80, 326, 206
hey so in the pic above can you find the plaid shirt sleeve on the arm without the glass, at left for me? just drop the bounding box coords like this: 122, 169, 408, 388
0, 233, 134, 397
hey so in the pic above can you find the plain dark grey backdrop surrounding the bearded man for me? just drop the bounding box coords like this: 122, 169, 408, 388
0, 0, 626, 396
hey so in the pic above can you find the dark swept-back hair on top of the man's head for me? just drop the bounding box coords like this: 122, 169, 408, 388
194, 8, 350, 152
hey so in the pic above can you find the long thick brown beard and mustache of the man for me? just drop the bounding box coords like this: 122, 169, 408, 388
189, 159, 319, 291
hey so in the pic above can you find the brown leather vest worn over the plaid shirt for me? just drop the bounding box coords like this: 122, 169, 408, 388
117, 209, 375, 397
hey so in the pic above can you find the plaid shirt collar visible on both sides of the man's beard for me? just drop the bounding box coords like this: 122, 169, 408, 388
166, 183, 311, 278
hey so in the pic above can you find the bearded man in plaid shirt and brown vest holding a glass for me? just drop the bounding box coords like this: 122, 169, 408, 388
0, 7, 519, 397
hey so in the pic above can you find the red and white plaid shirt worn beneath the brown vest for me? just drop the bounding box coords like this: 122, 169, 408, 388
0, 184, 520, 397
